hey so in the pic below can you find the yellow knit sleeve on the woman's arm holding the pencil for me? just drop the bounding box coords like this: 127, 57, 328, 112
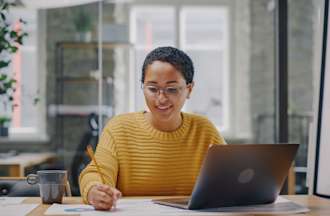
79, 127, 118, 203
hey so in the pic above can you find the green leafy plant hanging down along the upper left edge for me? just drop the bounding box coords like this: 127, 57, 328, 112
0, 0, 27, 136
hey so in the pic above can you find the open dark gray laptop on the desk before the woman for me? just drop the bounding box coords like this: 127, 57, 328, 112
153, 144, 299, 210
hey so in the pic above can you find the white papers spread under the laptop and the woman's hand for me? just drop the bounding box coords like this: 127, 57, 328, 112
45, 197, 308, 216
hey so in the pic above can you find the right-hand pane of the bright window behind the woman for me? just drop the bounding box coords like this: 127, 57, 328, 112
180, 7, 230, 131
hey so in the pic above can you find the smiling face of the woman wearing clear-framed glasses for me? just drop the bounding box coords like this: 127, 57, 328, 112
143, 61, 193, 122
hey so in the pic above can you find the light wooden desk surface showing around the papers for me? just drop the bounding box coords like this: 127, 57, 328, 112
23, 195, 330, 216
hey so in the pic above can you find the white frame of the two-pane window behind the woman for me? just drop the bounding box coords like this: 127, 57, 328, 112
129, 3, 237, 138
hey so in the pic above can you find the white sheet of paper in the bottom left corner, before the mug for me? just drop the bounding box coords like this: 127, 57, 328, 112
0, 203, 39, 216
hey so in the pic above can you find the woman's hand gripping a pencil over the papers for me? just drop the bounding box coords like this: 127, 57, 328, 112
87, 184, 121, 210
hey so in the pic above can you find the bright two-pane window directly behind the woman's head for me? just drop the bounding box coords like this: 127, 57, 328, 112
131, 6, 229, 131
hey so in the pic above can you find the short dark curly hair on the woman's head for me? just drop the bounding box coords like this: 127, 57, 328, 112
141, 47, 194, 84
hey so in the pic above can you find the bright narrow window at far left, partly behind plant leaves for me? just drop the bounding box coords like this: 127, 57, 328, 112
5, 8, 46, 139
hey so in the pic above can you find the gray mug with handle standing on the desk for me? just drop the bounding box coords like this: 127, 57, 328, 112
26, 170, 68, 204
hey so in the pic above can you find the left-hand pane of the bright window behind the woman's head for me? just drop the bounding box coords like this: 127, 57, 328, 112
130, 6, 176, 110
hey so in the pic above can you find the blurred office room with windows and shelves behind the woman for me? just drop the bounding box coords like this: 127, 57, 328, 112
0, 0, 323, 195
